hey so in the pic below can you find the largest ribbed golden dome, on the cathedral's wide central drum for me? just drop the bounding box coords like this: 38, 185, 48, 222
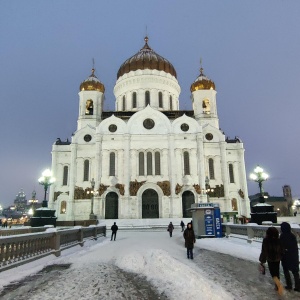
117, 36, 177, 78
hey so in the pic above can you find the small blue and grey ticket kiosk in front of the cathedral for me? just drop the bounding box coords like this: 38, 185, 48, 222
189, 202, 222, 239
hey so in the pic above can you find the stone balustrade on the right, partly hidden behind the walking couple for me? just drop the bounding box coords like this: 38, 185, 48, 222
222, 224, 300, 244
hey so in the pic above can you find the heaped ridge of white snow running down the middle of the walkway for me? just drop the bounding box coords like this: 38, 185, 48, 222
115, 249, 232, 300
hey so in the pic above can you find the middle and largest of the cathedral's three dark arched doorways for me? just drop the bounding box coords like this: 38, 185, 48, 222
142, 189, 159, 219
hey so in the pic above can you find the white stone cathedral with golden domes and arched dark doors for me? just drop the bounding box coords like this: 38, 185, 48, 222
49, 37, 250, 221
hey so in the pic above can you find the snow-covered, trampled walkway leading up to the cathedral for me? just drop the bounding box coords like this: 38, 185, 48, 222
0, 229, 299, 300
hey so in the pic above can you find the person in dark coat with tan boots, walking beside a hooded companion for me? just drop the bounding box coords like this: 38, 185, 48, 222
259, 227, 283, 295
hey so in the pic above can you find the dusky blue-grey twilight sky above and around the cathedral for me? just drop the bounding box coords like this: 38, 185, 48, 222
0, 0, 300, 206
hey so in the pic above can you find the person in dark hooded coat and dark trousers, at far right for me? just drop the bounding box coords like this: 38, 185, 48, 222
280, 222, 300, 292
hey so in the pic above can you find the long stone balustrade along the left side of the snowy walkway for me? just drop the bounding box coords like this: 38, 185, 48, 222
0, 226, 106, 272
